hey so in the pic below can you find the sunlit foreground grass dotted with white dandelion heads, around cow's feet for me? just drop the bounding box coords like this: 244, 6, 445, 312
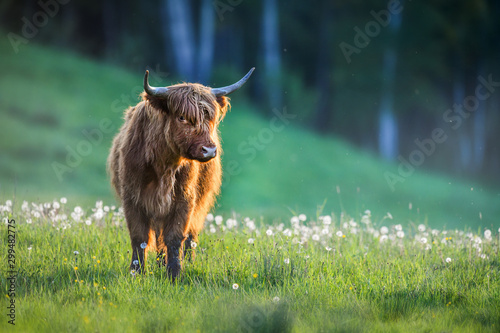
0, 198, 500, 332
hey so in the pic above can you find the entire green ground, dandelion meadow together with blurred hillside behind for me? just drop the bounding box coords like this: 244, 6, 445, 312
0, 40, 500, 332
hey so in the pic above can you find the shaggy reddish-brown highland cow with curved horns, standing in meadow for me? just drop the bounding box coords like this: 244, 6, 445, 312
108, 68, 254, 280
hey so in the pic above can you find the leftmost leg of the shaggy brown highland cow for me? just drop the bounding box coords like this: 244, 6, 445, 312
124, 204, 149, 273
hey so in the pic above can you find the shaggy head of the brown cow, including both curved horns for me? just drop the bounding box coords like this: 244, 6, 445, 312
143, 68, 254, 162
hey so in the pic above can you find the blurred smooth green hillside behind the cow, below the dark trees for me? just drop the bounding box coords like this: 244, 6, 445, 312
0, 37, 500, 227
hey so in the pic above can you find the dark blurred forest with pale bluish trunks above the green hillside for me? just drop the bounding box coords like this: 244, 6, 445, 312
0, 0, 500, 181
